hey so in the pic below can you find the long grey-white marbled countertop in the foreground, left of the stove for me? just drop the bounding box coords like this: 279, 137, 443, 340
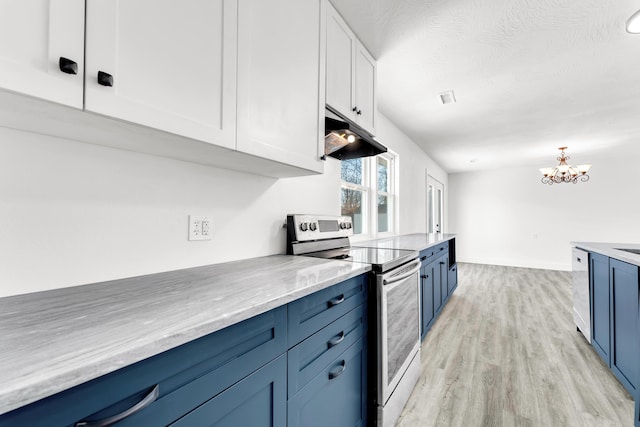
0, 255, 371, 414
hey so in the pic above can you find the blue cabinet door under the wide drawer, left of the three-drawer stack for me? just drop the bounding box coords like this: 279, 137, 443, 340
169, 354, 287, 427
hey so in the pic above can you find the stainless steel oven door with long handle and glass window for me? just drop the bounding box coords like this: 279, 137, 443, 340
377, 260, 421, 406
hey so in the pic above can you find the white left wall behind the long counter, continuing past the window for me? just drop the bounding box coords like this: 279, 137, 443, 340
0, 113, 440, 297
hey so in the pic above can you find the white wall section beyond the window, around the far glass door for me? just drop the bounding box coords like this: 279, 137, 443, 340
376, 114, 451, 234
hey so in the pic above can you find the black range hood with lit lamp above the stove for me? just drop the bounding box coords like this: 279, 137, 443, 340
324, 107, 387, 160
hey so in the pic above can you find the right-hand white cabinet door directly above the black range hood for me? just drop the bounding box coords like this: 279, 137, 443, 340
355, 43, 377, 135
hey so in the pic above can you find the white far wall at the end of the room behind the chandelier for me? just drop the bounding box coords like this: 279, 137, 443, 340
449, 158, 640, 270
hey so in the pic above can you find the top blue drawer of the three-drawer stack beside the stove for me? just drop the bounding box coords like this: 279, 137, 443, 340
287, 274, 368, 348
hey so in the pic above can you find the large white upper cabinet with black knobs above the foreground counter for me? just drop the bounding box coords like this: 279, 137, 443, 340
0, 0, 326, 177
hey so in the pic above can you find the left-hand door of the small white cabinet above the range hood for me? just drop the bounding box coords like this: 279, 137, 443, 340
326, 5, 356, 120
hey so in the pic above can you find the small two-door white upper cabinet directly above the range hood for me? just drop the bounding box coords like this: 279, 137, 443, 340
326, 4, 376, 134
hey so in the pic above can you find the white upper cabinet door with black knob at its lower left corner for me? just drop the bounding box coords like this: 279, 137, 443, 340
85, 0, 237, 148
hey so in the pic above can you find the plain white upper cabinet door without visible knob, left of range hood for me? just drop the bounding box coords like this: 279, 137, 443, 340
237, 0, 324, 176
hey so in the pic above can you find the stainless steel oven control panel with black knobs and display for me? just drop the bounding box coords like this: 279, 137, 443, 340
287, 215, 353, 242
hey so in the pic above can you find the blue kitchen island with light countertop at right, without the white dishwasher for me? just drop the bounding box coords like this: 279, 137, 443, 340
571, 242, 640, 427
